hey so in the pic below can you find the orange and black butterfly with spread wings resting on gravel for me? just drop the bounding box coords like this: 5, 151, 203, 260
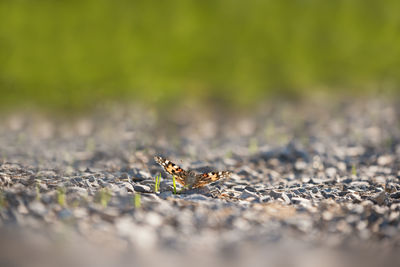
154, 157, 231, 188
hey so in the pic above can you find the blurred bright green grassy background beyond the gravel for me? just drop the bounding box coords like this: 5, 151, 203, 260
0, 0, 400, 111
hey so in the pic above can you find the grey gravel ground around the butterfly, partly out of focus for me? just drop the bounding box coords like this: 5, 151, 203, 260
0, 100, 400, 266
